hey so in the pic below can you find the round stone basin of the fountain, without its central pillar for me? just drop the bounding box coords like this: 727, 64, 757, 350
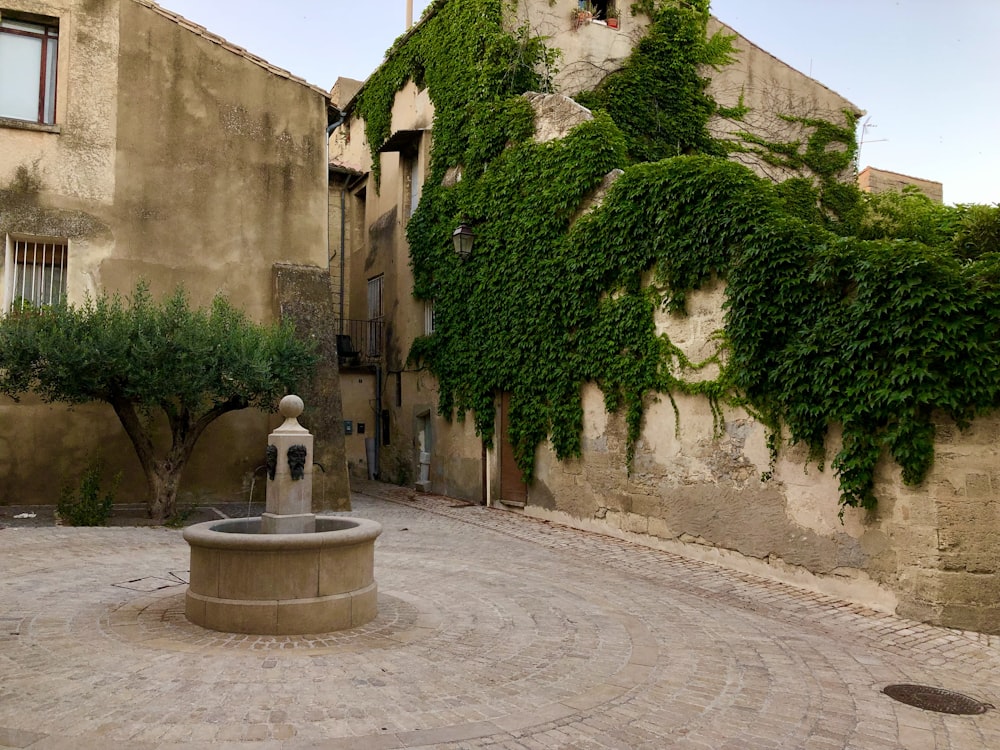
184, 516, 382, 635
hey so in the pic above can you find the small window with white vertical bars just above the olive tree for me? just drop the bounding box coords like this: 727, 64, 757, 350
3, 237, 69, 312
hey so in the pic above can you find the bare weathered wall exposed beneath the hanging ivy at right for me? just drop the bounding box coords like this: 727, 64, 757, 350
526, 284, 1000, 633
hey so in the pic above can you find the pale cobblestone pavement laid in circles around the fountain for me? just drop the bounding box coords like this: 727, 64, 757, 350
0, 484, 1000, 750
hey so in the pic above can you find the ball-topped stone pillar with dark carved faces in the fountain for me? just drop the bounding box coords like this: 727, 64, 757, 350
260, 396, 316, 534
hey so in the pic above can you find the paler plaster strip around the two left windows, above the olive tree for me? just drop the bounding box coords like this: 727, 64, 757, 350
0, 0, 121, 300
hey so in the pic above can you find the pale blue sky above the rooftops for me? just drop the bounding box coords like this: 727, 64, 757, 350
160, 0, 1000, 204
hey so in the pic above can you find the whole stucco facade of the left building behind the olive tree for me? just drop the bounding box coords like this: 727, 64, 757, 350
0, 0, 347, 506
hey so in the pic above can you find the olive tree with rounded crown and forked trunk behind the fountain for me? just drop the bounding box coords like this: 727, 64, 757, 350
0, 282, 316, 520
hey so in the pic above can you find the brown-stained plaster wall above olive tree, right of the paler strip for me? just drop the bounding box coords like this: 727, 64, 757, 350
114, 2, 327, 320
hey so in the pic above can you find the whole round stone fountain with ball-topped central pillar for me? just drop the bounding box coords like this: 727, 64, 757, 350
184, 396, 382, 635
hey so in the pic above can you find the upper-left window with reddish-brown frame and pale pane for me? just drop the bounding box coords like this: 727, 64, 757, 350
0, 14, 59, 125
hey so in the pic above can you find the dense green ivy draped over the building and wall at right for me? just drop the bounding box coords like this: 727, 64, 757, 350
357, 0, 1000, 507
